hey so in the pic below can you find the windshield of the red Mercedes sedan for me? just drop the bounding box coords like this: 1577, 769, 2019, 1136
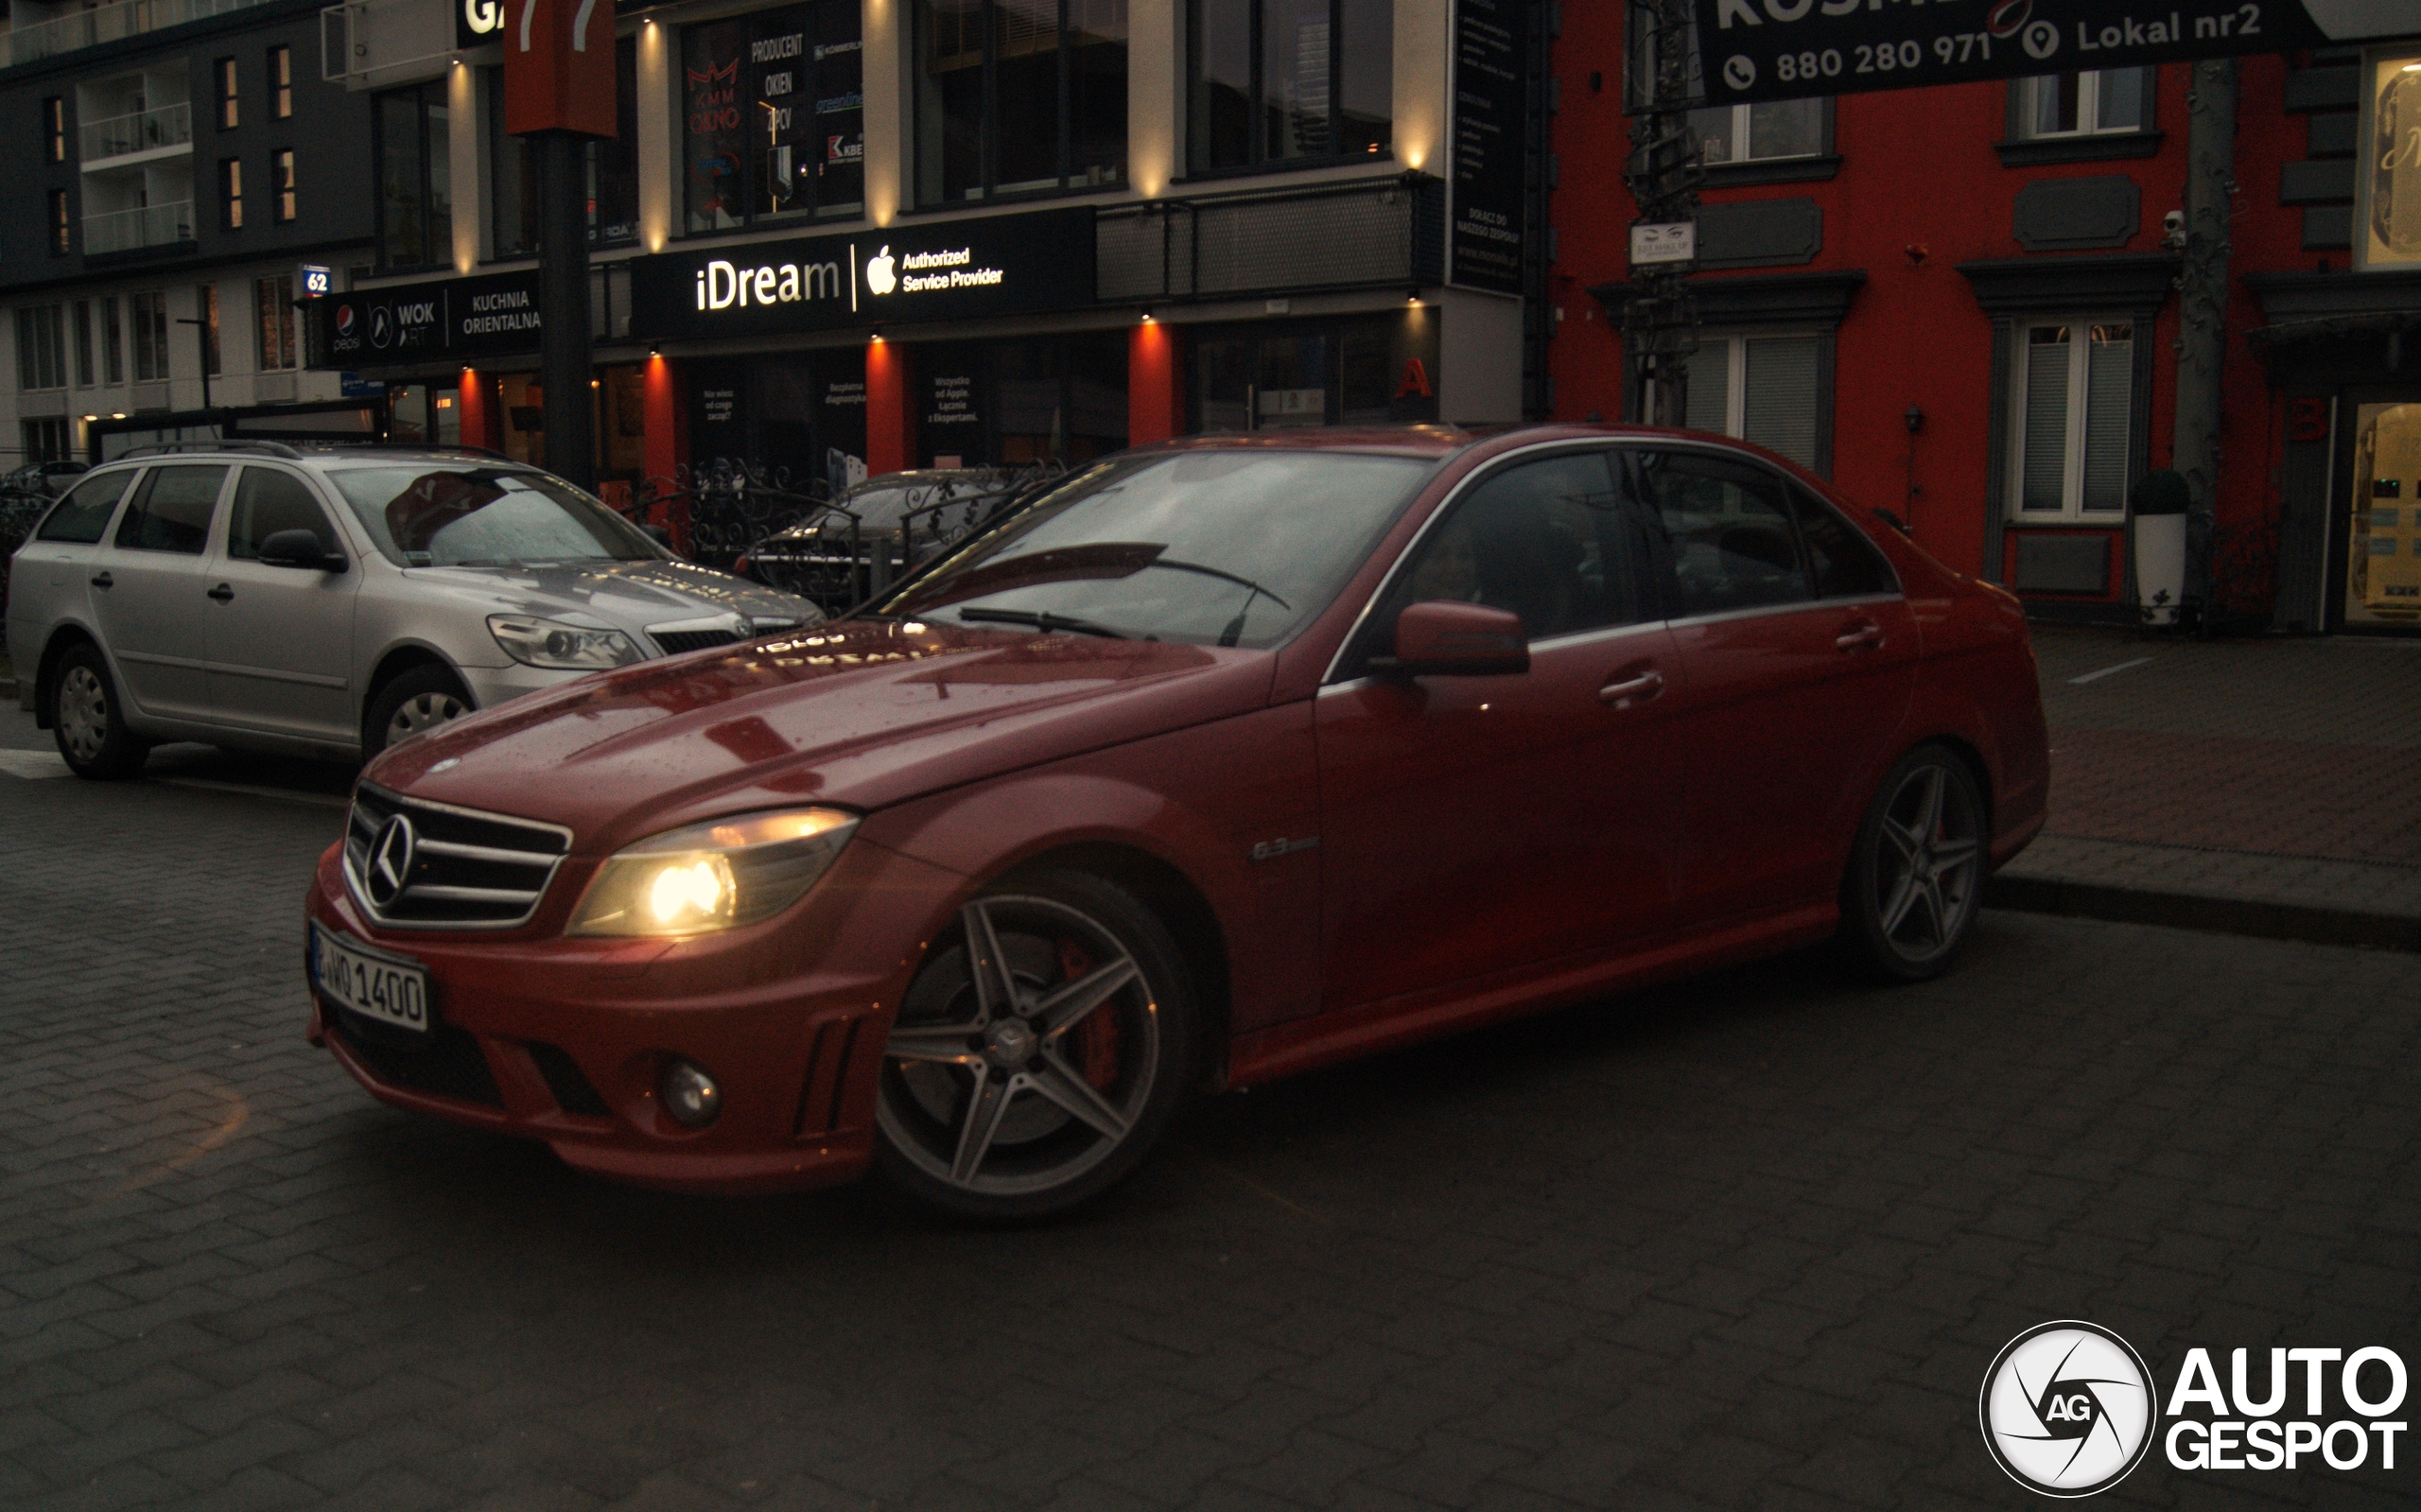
879, 450, 1431, 649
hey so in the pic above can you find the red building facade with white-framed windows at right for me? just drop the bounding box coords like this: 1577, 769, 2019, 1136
1549, 19, 2421, 632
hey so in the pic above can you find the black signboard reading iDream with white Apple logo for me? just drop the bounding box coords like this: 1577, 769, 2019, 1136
630, 208, 1094, 341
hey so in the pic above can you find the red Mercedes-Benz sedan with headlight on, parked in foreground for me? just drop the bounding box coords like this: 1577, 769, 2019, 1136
310, 426, 2046, 1217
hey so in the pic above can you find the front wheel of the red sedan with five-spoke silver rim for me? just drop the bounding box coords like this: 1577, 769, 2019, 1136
874, 871, 1198, 1222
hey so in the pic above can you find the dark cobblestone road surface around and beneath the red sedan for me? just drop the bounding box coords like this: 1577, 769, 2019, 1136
0, 711, 2421, 1512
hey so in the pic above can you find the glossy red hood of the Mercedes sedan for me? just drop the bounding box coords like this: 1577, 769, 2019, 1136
363, 619, 1274, 854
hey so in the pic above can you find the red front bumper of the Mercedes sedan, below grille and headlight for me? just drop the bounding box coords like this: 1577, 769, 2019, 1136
307, 840, 964, 1192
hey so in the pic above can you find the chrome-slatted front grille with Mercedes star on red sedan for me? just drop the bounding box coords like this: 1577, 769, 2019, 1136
344, 784, 571, 929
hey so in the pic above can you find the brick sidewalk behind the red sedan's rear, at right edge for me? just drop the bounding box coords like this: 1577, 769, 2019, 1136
1993, 627, 2421, 948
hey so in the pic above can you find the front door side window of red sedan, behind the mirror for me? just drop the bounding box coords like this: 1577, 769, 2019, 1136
1383, 452, 1648, 641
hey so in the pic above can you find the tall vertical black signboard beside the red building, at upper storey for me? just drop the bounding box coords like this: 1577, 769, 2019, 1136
1448, 0, 1530, 295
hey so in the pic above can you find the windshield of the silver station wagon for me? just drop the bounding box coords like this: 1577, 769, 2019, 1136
329, 462, 663, 566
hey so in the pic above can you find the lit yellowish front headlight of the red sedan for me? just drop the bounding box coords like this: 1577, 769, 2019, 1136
569, 808, 857, 936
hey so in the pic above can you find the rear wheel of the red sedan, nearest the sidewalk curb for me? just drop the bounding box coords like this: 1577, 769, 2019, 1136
1840, 745, 1990, 982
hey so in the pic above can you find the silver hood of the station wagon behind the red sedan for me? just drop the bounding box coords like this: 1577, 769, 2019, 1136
405, 562, 823, 632
